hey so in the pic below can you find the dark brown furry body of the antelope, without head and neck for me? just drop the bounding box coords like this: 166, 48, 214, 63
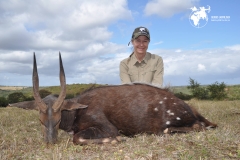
68, 84, 217, 144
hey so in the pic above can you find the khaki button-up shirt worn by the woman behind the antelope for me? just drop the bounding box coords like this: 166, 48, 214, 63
120, 52, 164, 87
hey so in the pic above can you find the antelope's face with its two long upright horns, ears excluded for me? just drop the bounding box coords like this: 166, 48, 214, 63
32, 53, 66, 143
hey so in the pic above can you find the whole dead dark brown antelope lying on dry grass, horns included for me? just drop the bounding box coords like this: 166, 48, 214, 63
11, 53, 217, 145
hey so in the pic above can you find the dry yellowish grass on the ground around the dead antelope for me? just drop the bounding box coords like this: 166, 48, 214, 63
0, 100, 240, 160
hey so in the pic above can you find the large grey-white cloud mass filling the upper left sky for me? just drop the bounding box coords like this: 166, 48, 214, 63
0, 0, 132, 51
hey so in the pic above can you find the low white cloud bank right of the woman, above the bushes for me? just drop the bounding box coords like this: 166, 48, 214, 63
150, 48, 240, 85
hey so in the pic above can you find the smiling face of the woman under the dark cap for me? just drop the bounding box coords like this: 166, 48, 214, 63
132, 36, 149, 55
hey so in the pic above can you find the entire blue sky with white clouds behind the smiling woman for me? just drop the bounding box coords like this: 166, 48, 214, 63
0, 0, 240, 86
